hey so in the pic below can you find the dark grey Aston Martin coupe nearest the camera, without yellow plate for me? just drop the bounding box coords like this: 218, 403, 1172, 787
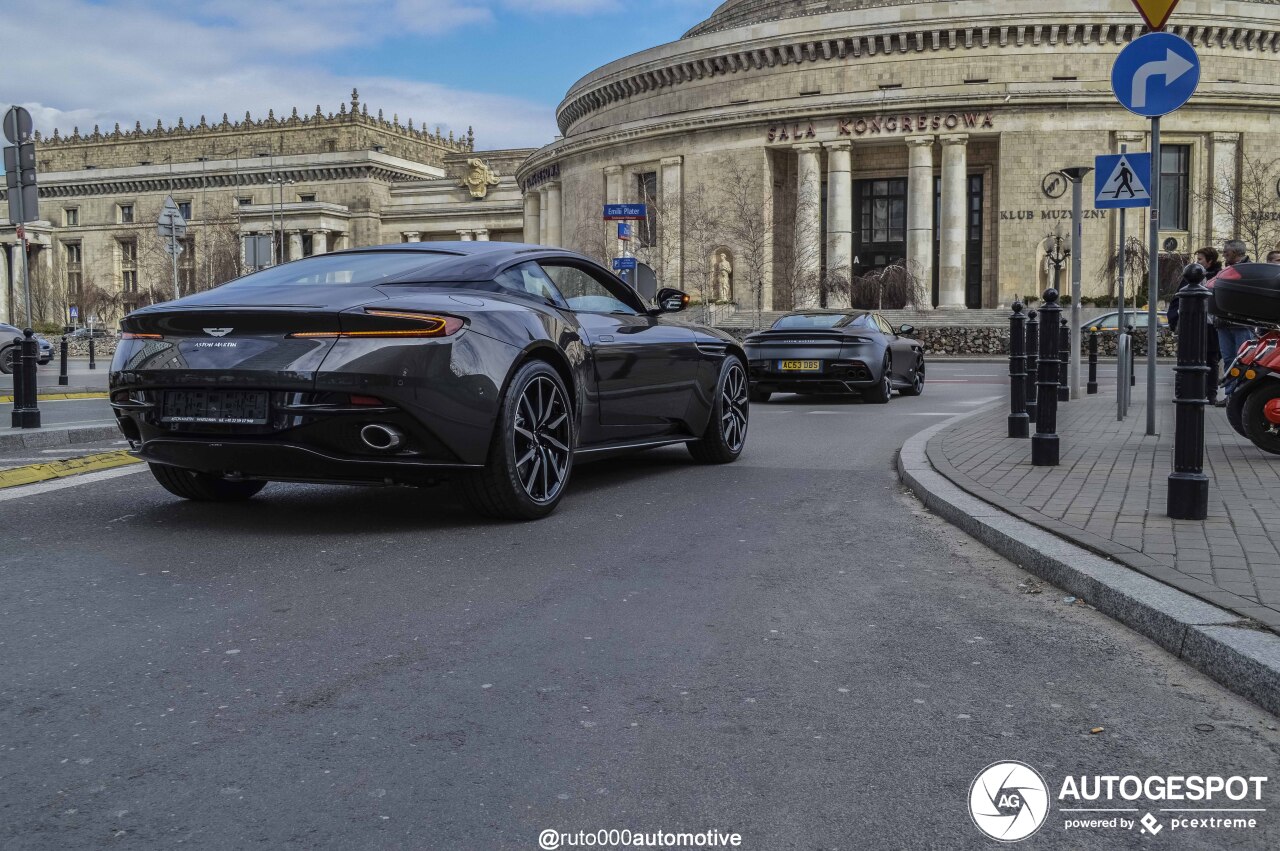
111, 242, 749, 520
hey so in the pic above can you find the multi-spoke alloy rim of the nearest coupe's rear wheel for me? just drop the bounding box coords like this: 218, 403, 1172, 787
515, 375, 572, 503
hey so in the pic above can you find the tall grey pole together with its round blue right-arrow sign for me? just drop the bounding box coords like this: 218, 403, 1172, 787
1111, 29, 1199, 435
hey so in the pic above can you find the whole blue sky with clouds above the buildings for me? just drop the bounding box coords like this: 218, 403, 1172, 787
0, 0, 717, 148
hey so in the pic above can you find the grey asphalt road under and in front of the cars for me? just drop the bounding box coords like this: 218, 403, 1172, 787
0, 363, 1280, 851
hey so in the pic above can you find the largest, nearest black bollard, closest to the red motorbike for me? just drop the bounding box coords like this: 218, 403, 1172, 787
1166, 264, 1210, 520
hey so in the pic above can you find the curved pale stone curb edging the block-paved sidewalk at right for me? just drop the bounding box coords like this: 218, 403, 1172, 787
897, 408, 1280, 715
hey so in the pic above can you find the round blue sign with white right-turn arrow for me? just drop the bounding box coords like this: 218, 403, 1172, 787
1111, 32, 1199, 118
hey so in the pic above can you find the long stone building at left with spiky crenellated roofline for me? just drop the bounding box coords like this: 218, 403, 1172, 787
0, 92, 530, 324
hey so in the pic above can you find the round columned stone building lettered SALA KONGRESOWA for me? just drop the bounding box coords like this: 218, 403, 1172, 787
517, 0, 1280, 310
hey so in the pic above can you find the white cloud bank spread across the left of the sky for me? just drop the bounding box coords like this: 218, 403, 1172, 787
0, 0, 581, 147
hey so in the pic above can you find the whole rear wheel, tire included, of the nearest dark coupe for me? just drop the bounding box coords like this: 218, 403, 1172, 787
461, 361, 577, 520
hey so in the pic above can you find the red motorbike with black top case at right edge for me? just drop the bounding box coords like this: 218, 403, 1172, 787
1213, 264, 1280, 454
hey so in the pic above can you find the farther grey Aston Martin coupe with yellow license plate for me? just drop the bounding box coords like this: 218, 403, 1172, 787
745, 310, 924, 403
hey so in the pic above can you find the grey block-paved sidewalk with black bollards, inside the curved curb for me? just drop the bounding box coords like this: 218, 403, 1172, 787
927, 366, 1280, 631
